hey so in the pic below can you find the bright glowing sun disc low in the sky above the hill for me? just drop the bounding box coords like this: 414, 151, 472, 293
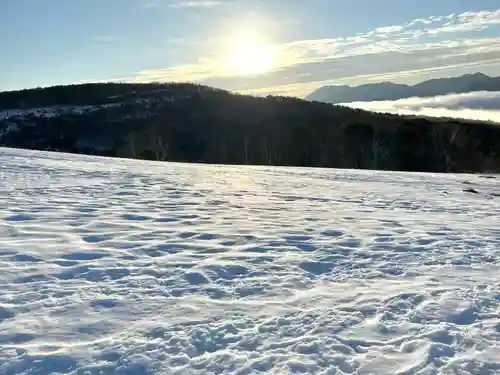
228, 42, 275, 75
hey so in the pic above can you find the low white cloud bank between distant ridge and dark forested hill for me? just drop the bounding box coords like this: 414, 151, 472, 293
342, 91, 500, 123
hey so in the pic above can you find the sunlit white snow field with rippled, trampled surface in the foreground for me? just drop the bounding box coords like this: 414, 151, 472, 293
0, 149, 500, 375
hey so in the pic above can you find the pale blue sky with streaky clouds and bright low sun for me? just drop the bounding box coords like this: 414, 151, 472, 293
0, 0, 500, 97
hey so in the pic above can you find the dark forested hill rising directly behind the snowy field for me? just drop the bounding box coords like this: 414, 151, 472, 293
0, 83, 500, 172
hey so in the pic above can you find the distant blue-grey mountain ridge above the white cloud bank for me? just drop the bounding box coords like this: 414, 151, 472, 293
306, 73, 500, 104
